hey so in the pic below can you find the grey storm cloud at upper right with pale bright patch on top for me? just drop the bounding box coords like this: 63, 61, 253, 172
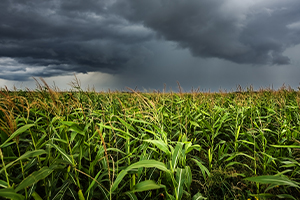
115, 0, 300, 65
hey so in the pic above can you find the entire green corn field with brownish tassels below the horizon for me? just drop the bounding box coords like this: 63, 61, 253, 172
0, 79, 300, 200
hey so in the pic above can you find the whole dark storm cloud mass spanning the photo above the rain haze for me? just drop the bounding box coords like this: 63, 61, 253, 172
0, 0, 300, 80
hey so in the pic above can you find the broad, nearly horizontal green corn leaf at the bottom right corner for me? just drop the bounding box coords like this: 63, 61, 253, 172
245, 175, 300, 188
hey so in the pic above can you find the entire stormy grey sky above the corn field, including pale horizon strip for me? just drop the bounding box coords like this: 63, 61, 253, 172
0, 0, 300, 92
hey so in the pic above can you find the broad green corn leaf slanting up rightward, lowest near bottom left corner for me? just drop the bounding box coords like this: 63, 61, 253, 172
15, 167, 53, 192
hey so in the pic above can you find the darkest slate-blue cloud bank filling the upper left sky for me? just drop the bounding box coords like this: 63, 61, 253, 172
0, 0, 153, 79
